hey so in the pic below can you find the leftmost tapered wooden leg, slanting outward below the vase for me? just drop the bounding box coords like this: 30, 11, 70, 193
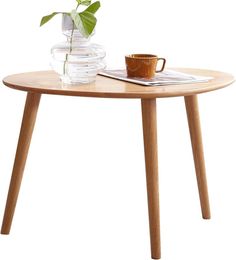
1, 93, 41, 234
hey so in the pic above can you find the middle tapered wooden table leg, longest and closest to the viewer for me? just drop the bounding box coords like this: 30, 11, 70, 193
142, 99, 161, 259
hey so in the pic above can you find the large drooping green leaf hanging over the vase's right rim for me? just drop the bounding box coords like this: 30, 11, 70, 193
71, 10, 97, 38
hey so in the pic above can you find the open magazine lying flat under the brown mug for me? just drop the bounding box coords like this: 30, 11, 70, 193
99, 69, 212, 86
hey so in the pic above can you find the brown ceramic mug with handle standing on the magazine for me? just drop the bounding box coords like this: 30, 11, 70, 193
125, 54, 166, 79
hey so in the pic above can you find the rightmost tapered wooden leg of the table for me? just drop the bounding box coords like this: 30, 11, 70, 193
185, 95, 211, 219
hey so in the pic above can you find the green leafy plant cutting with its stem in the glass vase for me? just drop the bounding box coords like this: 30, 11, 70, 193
40, 0, 100, 78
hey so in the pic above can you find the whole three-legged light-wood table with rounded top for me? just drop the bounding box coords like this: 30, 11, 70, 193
1, 68, 234, 259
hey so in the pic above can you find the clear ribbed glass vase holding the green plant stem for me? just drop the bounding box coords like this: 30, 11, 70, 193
51, 15, 106, 84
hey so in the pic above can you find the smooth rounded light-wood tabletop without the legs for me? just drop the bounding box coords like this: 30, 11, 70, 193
3, 68, 234, 98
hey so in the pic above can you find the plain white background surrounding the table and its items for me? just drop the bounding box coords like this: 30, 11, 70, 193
0, 0, 236, 260
